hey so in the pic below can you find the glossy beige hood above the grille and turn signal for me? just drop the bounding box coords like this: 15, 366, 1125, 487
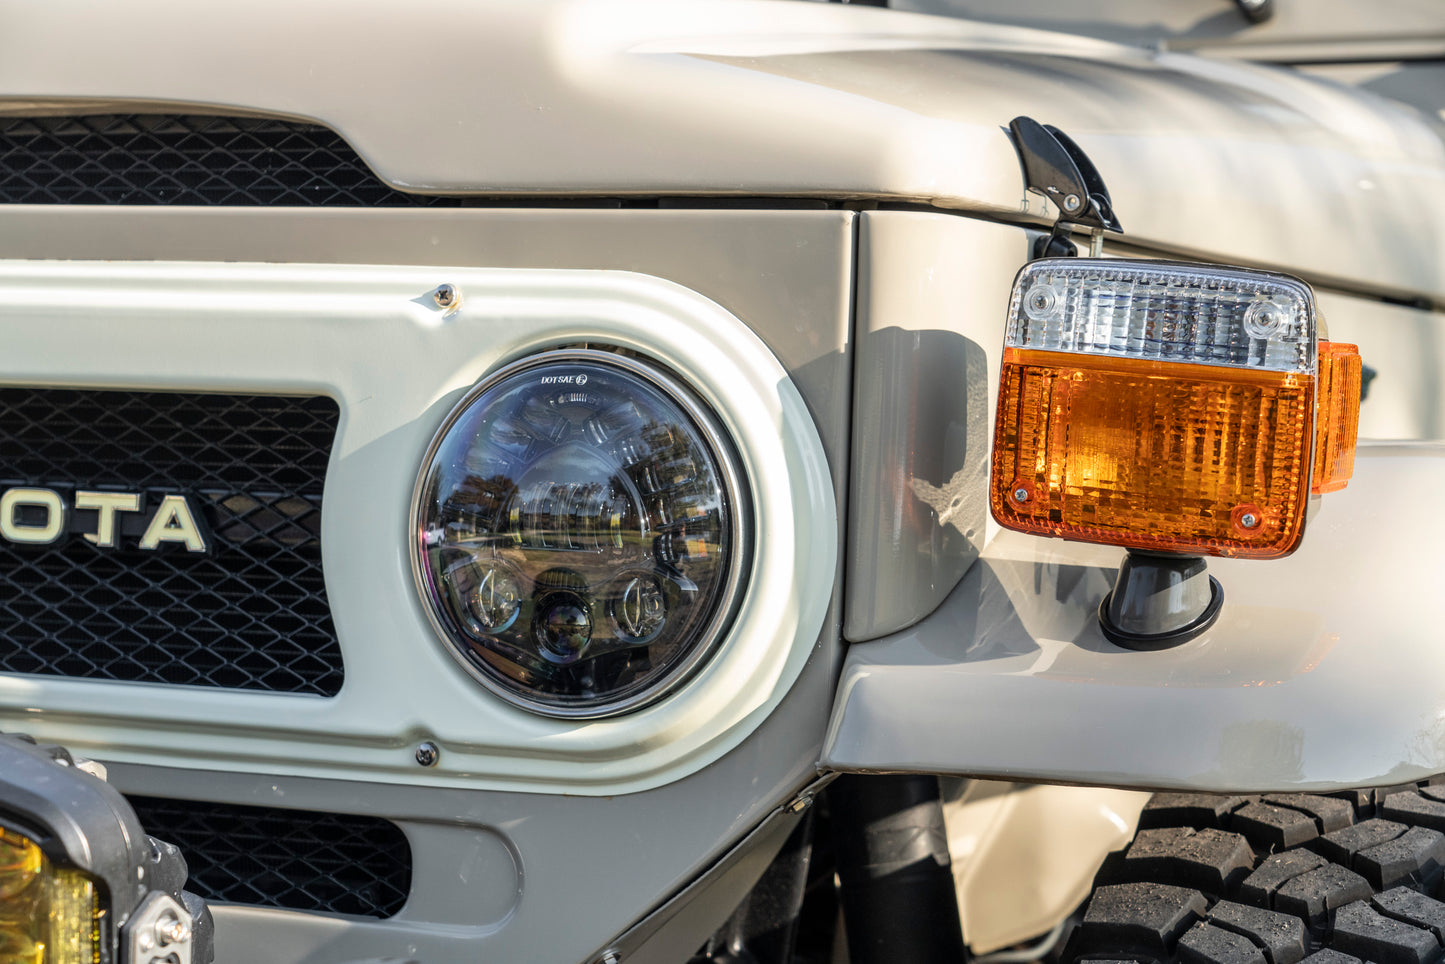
0, 0, 1445, 304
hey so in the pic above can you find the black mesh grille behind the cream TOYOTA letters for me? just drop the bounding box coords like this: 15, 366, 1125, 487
0, 389, 342, 695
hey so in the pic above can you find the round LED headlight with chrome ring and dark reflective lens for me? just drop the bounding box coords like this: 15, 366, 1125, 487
412, 350, 751, 717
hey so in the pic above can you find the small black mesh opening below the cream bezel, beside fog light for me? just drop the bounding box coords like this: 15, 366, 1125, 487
130, 796, 412, 918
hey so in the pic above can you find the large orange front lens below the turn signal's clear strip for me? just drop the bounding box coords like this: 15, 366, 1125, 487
990, 348, 1315, 558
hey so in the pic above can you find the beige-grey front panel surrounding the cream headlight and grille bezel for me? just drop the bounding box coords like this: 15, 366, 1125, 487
0, 208, 853, 964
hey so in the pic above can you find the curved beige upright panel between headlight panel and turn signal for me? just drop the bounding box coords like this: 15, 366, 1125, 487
844, 211, 1030, 642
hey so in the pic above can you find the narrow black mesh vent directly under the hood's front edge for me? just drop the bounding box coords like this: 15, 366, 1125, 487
0, 114, 462, 207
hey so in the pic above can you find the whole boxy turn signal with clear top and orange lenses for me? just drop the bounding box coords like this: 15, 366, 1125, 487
990, 259, 1360, 559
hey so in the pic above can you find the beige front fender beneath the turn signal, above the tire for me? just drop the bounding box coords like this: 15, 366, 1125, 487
822, 444, 1445, 792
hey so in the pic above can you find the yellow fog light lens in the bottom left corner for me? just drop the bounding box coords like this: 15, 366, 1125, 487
0, 827, 100, 964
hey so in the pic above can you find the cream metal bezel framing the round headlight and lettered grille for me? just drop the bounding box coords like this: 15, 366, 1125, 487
0, 262, 838, 795
